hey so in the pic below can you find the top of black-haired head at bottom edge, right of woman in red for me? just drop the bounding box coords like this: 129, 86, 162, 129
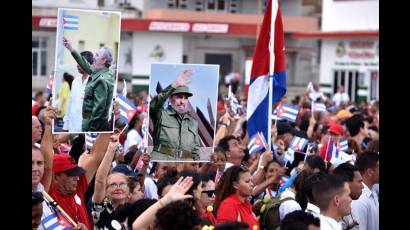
280, 210, 320, 230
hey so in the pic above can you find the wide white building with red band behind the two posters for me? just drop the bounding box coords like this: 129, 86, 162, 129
32, 0, 319, 98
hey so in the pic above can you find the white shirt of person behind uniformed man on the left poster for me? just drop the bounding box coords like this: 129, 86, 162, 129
63, 76, 89, 133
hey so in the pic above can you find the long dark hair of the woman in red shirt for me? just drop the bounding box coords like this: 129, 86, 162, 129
214, 165, 249, 213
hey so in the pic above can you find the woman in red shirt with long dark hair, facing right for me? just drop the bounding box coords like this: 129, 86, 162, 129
215, 165, 260, 230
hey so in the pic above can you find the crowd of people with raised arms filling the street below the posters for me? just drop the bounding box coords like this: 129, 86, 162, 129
32, 80, 379, 230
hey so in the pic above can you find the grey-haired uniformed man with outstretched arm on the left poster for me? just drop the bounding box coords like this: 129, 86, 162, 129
63, 38, 114, 132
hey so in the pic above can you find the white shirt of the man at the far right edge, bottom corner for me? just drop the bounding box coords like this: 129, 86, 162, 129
352, 183, 379, 230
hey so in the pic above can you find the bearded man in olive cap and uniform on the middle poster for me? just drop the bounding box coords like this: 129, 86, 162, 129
149, 69, 200, 161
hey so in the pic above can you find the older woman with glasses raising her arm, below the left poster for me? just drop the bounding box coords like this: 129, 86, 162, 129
92, 135, 131, 230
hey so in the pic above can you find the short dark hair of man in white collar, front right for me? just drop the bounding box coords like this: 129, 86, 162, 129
312, 174, 345, 210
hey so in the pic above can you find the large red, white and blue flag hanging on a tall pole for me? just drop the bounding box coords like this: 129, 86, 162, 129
247, 0, 286, 147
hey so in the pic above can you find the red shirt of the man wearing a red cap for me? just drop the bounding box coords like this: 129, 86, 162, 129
49, 174, 94, 229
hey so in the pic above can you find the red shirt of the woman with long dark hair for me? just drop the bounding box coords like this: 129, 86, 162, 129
216, 194, 260, 230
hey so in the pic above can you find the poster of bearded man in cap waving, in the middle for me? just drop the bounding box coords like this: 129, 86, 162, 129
148, 64, 219, 162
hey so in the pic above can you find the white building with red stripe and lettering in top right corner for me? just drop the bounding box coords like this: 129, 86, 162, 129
320, 0, 379, 102
